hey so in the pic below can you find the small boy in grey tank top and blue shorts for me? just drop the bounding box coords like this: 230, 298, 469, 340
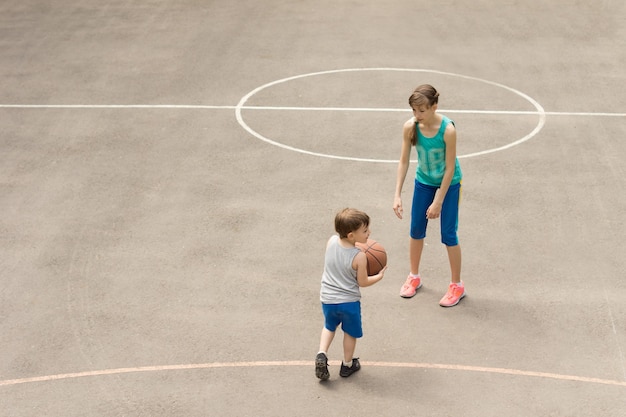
315, 208, 387, 381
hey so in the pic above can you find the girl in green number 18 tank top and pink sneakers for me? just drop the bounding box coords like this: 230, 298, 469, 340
393, 84, 465, 307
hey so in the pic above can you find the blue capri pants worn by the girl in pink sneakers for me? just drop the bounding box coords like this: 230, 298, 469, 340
410, 181, 461, 246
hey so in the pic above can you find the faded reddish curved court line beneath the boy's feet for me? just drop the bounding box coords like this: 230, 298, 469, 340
0, 361, 626, 387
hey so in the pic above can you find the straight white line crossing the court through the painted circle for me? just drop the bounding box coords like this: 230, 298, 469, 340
0, 104, 626, 117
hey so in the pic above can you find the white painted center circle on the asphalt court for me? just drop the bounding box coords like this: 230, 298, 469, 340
235, 68, 546, 163
